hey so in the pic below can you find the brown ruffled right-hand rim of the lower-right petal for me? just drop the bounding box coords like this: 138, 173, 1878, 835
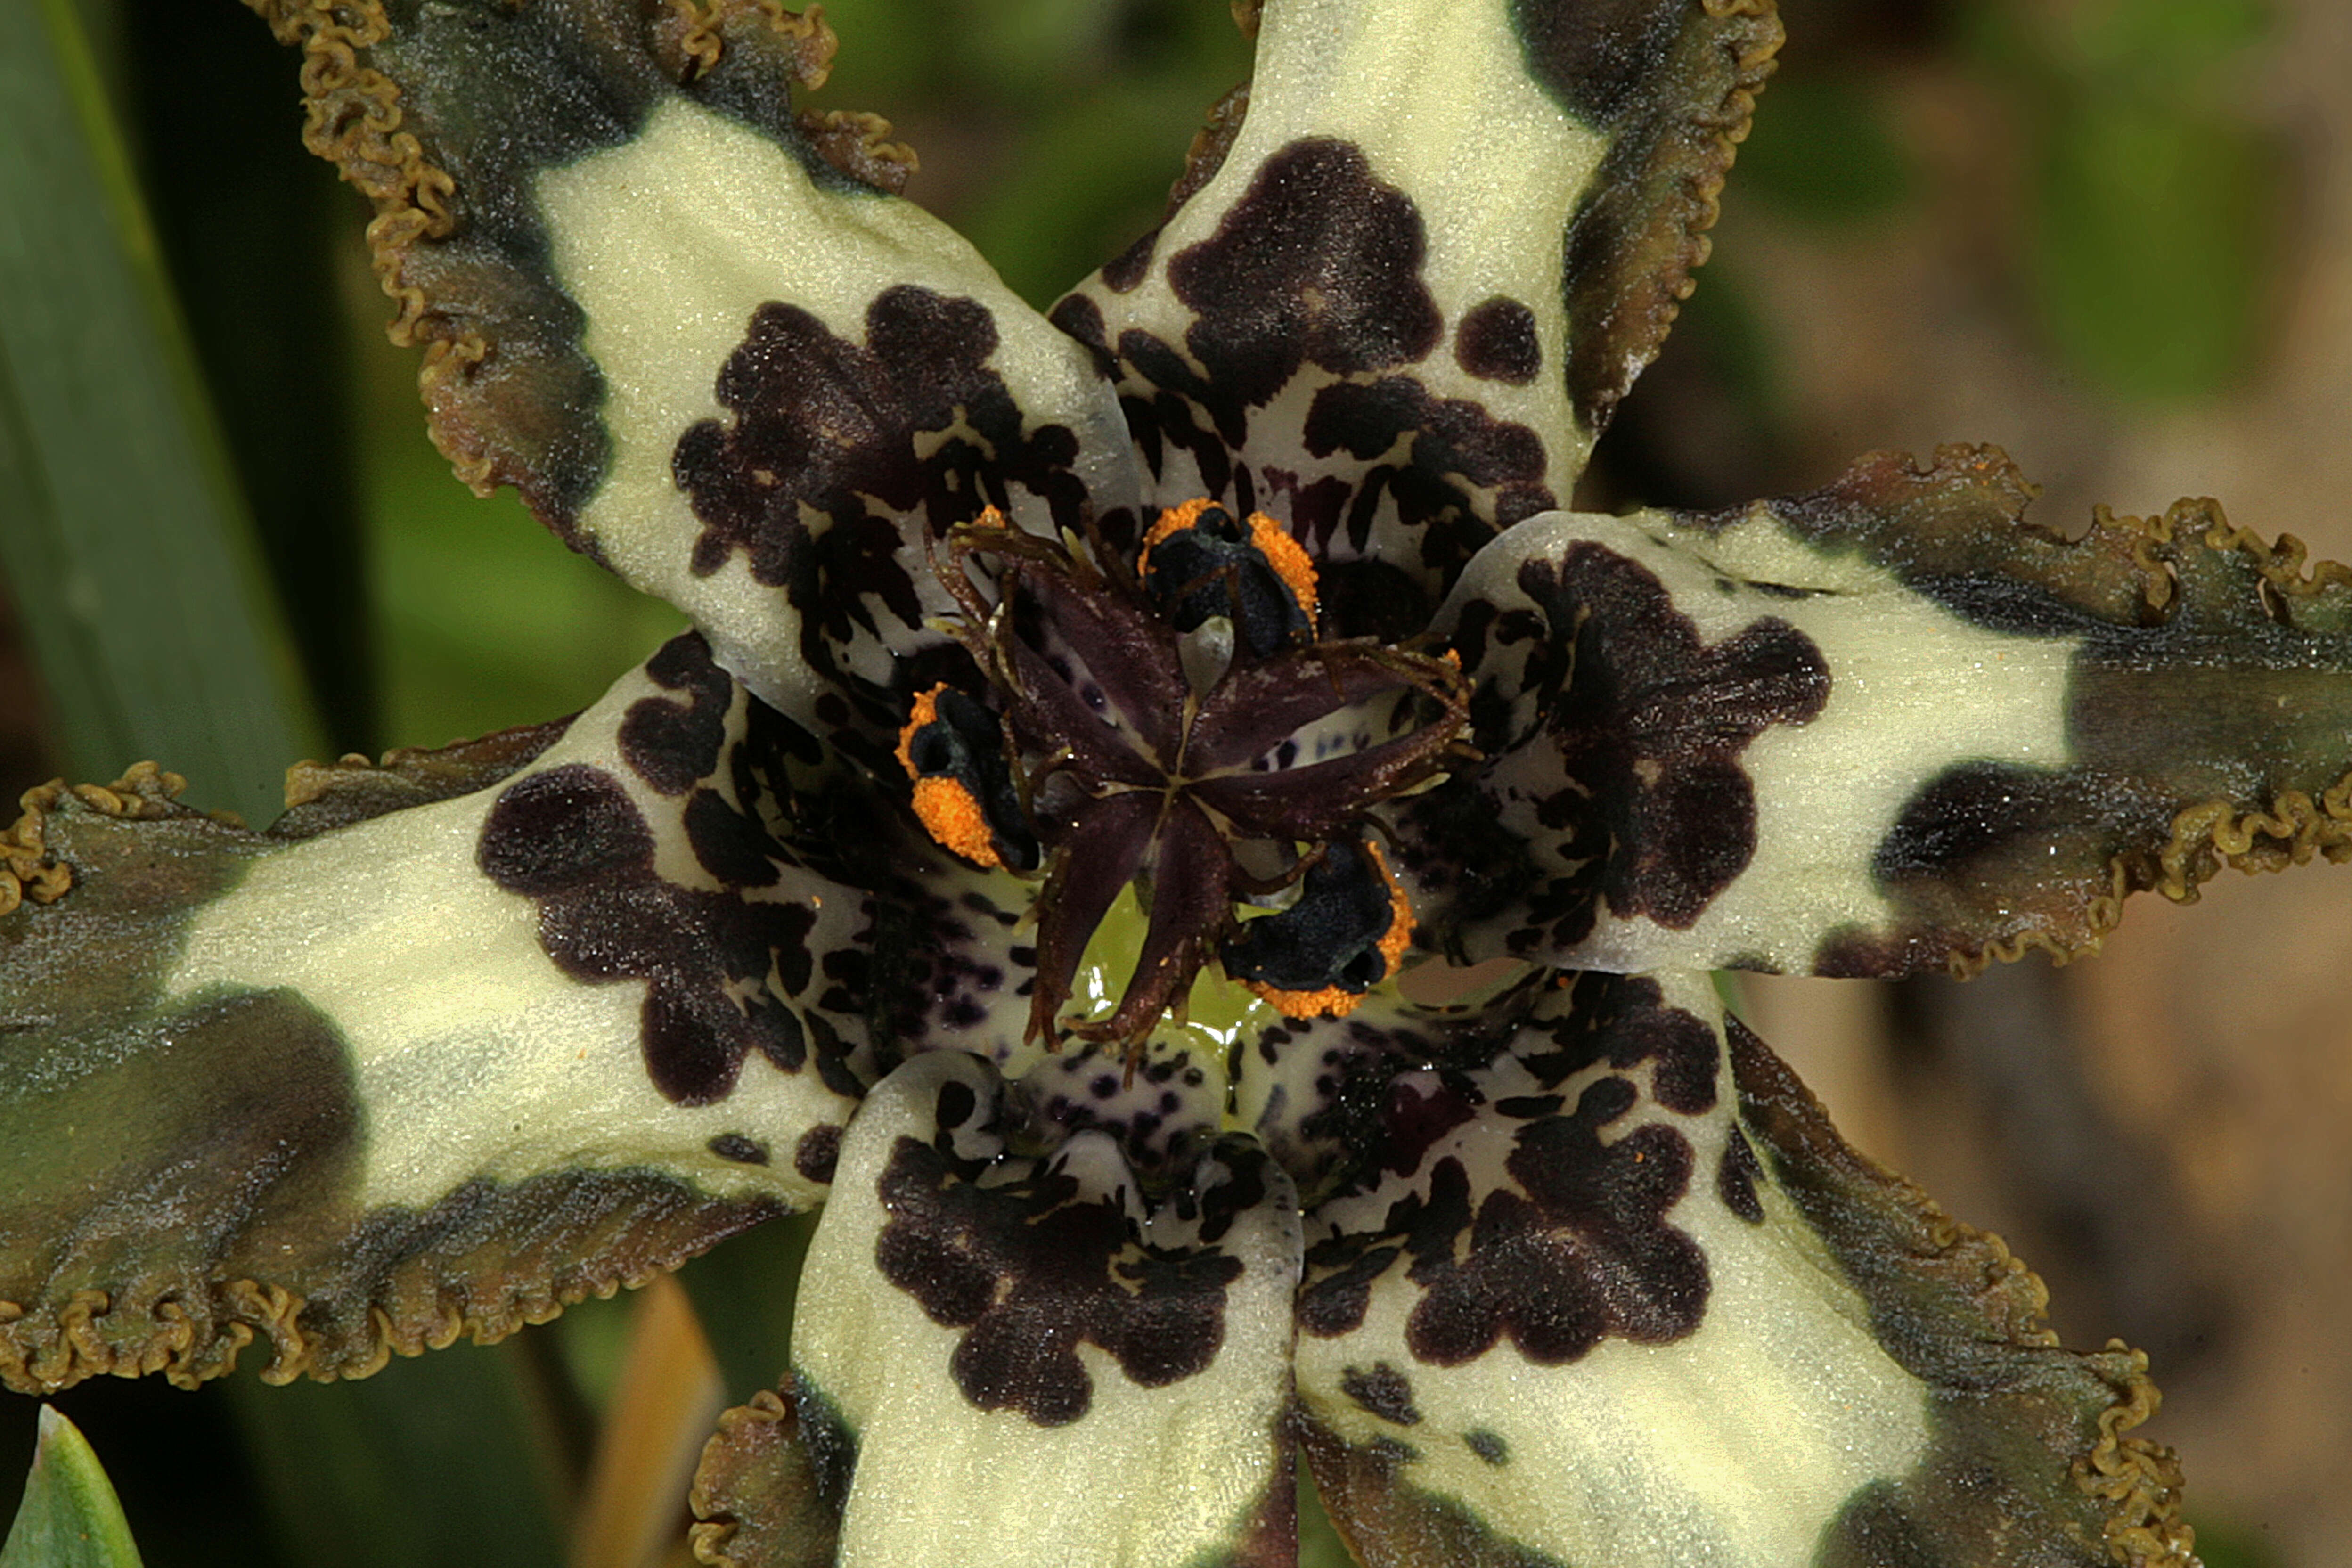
1729, 1022, 2197, 1568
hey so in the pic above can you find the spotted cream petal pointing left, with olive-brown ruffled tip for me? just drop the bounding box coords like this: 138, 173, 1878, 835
0, 637, 873, 1392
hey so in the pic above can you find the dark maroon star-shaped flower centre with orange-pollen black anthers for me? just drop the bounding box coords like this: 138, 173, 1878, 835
898, 501, 1468, 1046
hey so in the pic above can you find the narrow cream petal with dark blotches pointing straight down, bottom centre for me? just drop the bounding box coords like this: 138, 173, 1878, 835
792, 1053, 1298, 1568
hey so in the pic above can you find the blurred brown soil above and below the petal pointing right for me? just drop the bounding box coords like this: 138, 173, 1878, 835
1719, 0, 2352, 1568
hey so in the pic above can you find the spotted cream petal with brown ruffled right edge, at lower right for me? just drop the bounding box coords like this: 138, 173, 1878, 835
1298, 973, 2178, 1568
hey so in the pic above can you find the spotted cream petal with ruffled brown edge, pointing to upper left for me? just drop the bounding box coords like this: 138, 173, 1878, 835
252, 0, 1134, 761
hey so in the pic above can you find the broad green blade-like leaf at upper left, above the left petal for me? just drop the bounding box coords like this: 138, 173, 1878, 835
0, 0, 318, 818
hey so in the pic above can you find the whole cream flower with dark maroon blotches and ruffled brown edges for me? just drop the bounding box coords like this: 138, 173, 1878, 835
0, 0, 2352, 1568
